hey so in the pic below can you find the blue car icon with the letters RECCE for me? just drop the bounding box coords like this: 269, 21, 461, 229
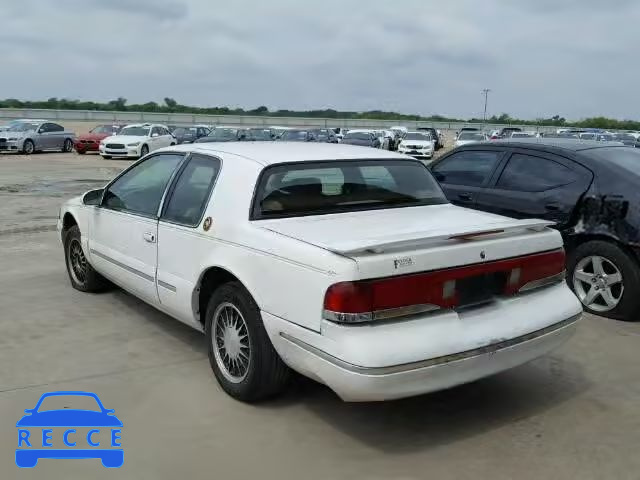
16, 391, 124, 468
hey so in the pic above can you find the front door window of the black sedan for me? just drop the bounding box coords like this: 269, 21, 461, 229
433, 150, 502, 187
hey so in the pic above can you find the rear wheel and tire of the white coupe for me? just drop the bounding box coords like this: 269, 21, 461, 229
205, 282, 291, 402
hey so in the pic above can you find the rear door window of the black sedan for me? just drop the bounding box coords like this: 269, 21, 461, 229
496, 153, 577, 192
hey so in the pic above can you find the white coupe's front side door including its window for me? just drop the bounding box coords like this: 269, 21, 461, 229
89, 153, 184, 303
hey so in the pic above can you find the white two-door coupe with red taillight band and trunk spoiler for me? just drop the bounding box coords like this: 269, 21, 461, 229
58, 142, 582, 401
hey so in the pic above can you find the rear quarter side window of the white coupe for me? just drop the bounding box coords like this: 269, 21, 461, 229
162, 154, 220, 227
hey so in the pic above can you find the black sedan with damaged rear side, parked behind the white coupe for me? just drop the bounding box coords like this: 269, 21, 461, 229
431, 138, 640, 320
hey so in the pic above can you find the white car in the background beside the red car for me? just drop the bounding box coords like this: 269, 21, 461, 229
98, 123, 177, 159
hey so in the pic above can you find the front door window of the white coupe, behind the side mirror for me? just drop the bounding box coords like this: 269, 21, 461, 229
102, 154, 183, 216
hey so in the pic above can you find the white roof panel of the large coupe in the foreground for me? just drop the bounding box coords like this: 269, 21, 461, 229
162, 142, 408, 165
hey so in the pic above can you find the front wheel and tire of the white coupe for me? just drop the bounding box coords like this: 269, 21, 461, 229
64, 225, 110, 293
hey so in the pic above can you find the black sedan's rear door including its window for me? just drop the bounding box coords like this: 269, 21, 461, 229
476, 149, 593, 229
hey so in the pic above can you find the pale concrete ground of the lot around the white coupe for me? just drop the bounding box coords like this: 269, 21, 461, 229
0, 154, 640, 480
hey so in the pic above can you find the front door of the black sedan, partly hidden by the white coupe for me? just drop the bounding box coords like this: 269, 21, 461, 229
432, 150, 504, 208
